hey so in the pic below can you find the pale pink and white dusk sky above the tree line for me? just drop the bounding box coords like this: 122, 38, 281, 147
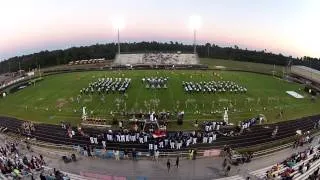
0, 0, 320, 60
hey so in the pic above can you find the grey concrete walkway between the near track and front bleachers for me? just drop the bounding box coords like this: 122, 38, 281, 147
0, 133, 317, 180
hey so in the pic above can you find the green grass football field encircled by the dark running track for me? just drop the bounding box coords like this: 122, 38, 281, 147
0, 59, 320, 129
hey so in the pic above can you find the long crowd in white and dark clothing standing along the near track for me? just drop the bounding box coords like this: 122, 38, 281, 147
73, 114, 264, 152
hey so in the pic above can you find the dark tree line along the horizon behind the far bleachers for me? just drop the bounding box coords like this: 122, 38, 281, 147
0, 41, 320, 73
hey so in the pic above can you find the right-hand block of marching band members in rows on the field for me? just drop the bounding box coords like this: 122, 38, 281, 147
182, 81, 247, 93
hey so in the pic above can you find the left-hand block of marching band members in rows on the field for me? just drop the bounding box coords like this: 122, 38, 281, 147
80, 78, 131, 94
